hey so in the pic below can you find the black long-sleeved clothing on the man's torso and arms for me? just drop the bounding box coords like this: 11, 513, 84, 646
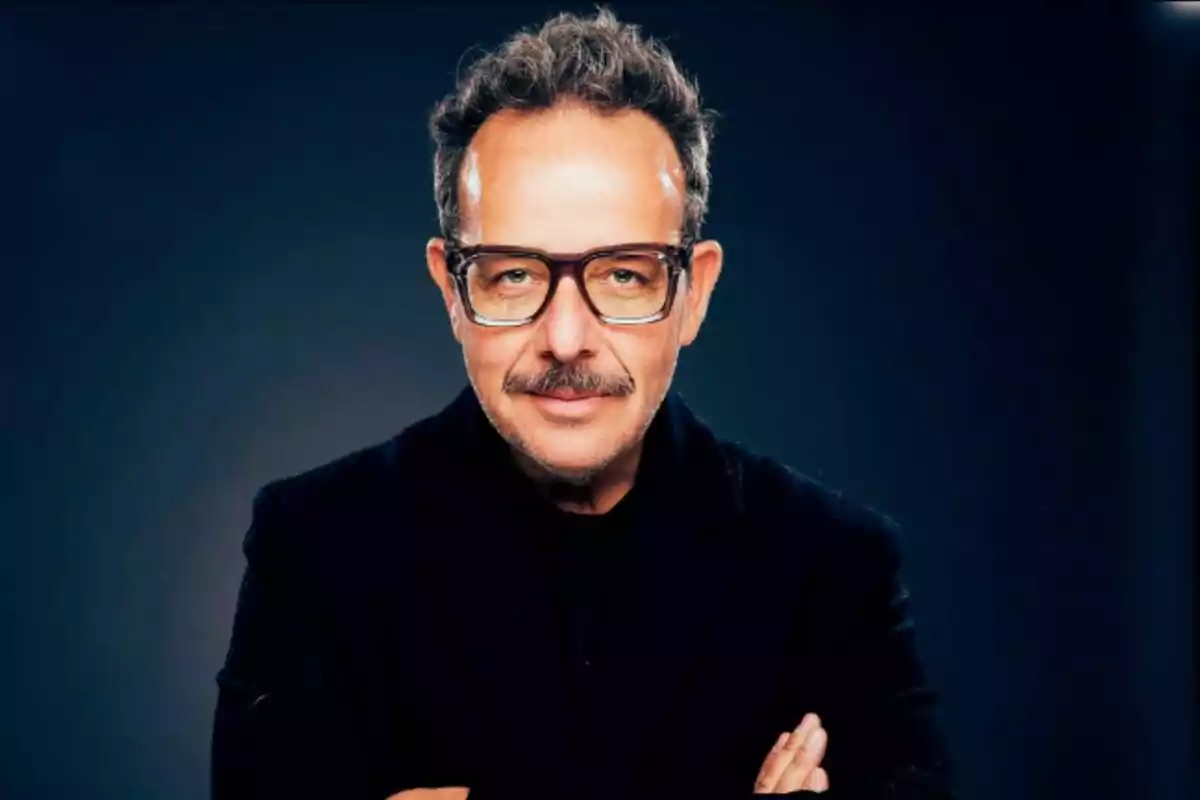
212, 389, 950, 800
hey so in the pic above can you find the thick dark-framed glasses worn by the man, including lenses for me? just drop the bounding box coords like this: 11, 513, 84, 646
446, 240, 691, 326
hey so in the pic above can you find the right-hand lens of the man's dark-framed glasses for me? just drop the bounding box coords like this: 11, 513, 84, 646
583, 251, 670, 319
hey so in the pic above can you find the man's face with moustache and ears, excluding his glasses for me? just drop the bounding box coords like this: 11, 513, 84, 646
426, 104, 721, 482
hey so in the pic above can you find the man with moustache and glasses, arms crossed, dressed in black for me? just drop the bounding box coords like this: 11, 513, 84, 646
212, 11, 949, 800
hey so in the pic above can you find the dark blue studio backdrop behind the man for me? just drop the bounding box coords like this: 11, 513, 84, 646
0, 4, 1200, 800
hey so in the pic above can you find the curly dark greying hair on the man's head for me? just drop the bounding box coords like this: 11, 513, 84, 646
430, 8, 716, 241
